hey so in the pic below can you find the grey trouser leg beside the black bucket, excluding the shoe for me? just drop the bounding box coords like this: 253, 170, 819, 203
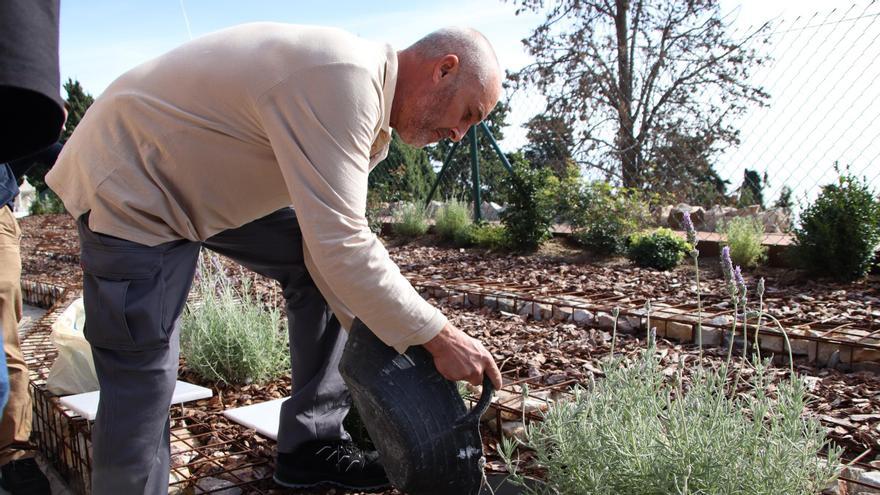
204, 208, 351, 453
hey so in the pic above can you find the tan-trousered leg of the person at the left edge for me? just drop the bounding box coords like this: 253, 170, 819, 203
0, 206, 33, 465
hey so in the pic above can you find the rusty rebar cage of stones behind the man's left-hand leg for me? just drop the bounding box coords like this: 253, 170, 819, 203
21, 282, 274, 495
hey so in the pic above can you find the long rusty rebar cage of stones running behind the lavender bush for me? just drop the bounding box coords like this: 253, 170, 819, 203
407, 274, 880, 364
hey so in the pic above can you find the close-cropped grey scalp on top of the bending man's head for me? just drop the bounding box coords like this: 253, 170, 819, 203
406, 27, 501, 93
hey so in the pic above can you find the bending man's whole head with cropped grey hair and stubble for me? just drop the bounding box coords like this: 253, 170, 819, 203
391, 27, 501, 146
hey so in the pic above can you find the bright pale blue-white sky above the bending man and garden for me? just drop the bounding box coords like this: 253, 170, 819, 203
60, 0, 880, 206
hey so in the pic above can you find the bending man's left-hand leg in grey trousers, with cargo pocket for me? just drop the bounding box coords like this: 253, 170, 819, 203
78, 216, 199, 495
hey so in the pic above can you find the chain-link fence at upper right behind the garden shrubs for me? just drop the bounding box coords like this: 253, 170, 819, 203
482, 1, 880, 232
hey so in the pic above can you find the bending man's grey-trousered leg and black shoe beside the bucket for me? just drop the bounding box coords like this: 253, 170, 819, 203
204, 208, 389, 490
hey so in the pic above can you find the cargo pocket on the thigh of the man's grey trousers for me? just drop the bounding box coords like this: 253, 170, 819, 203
80, 243, 168, 351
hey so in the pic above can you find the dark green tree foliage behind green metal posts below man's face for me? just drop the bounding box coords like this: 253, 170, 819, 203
428, 101, 511, 203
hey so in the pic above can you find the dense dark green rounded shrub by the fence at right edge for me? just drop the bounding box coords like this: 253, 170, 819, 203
792, 174, 880, 281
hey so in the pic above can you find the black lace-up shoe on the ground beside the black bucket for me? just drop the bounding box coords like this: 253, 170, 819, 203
273, 441, 391, 491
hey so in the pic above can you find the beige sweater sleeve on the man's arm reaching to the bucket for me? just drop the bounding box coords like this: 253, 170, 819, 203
257, 64, 447, 352
